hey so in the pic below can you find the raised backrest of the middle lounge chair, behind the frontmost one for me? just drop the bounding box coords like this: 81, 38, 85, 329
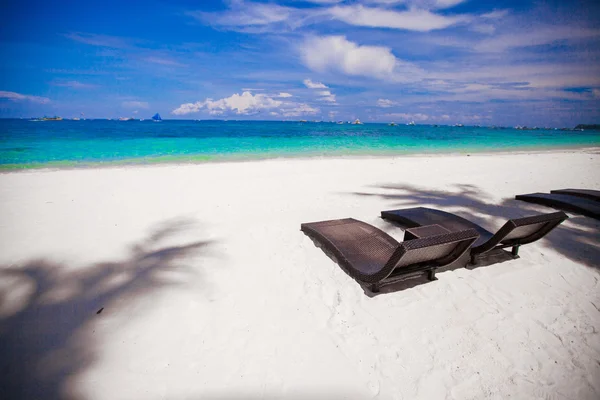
474, 211, 569, 253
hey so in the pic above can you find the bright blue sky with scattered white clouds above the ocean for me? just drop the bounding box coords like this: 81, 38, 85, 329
0, 0, 600, 126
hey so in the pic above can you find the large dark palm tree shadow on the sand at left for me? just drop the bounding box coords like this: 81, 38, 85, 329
0, 220, 213, 399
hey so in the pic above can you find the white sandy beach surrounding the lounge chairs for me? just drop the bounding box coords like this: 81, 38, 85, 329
0, 151, 600, 399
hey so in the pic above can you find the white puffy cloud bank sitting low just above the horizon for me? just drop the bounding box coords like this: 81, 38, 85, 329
172, 92, 283, 115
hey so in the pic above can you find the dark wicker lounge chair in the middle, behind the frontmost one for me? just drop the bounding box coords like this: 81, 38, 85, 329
381, 207, 568, 265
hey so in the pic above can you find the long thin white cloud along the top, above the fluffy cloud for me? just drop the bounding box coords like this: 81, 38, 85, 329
328, 5, 471, 32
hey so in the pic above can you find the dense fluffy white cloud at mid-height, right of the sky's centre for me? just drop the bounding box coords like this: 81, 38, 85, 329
300, 36, 405, 79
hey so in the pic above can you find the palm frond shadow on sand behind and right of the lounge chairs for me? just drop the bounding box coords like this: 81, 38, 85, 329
353, 184, 600, 269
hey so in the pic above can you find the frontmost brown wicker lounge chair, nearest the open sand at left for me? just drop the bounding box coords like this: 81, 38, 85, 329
301, 218, 477, 292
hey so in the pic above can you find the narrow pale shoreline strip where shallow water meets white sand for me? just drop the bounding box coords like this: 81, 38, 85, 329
0, 146, 600, 175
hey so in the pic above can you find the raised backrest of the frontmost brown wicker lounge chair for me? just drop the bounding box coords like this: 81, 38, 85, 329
387, 229, 479, 269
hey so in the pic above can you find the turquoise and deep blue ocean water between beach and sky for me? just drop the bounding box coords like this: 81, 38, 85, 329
0, 119, 600, 170
